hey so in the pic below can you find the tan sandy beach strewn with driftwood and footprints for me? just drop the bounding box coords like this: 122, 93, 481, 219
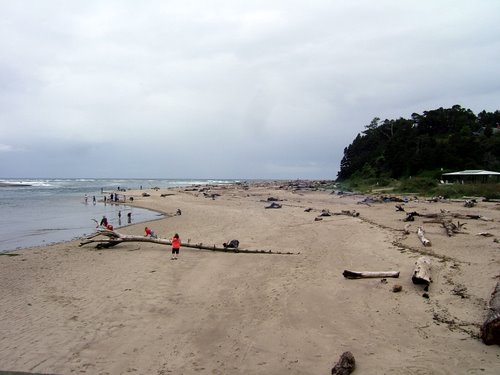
0, 183, 500, 375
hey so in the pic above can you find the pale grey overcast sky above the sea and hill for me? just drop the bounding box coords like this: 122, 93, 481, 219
0, 0, 500, 179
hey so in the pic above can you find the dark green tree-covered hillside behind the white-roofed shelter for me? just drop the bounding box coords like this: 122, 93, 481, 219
337, 105, 500, 180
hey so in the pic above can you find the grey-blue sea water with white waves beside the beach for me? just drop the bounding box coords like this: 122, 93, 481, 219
0, 178, 235, 253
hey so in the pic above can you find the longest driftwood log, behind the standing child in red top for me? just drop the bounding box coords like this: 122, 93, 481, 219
79, 229, 300, 255
